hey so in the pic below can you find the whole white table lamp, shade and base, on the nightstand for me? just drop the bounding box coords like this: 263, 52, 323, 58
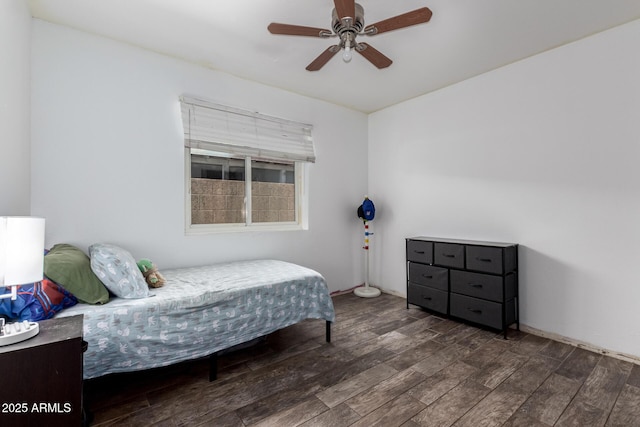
0, 216, 44, 346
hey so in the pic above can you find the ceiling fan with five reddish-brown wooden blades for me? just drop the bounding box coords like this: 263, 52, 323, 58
267, 0, 433, 71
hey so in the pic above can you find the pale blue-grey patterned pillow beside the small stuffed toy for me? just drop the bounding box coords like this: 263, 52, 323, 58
89, 243, 149, 298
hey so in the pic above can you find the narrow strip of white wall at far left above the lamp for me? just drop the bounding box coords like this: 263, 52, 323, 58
0, 0, 31, 215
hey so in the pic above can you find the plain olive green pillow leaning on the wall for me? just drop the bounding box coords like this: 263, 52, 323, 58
44, 244, 109, 304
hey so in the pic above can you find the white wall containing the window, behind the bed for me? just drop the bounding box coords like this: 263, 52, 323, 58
32, 20, 367, 296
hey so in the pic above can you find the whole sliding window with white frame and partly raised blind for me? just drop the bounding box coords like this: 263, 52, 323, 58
181, 97, 315, 233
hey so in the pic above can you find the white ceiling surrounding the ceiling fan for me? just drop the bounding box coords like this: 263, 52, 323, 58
27, 0, 640, 113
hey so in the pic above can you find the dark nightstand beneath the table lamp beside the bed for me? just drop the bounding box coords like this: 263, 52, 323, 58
0, 315, 83, 426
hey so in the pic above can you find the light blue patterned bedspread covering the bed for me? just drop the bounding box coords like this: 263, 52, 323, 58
57, 260, 335, 378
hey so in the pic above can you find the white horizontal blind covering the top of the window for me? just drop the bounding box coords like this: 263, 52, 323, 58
180, 96, 316, 162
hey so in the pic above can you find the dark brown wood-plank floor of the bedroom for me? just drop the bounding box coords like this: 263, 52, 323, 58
85, 294, 640, 427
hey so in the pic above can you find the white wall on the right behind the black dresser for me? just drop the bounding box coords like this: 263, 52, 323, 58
369, 21, 640, 356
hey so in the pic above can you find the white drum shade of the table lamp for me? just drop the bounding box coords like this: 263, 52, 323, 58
0, 217, 44, 286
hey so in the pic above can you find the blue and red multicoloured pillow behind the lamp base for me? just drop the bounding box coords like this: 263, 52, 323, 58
0, 279, 78, 322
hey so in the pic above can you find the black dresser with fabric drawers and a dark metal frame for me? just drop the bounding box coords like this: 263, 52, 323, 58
406, 237, 520, 338
